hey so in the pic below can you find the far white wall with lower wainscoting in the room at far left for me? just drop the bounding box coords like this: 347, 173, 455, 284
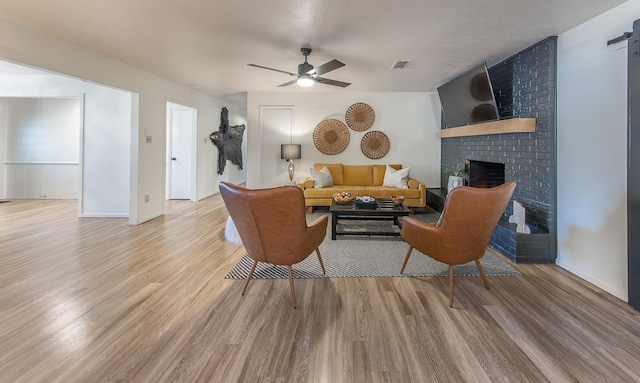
0, 97, 82, 199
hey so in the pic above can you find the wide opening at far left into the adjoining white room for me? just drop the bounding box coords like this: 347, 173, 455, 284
0, 60, 138, 224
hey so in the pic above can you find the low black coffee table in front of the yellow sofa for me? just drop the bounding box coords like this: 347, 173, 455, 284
329, 198, 411, 239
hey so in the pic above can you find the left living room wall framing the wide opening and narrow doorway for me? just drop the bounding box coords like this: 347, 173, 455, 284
0, 18, 244, 224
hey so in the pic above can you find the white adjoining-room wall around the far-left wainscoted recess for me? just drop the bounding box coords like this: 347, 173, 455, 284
0, 72, 131, 217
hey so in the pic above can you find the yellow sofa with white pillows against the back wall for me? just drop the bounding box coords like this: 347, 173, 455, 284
298, 163, 427, 214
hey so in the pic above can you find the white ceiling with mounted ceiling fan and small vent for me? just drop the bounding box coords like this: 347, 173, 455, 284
0, 0, 631, 95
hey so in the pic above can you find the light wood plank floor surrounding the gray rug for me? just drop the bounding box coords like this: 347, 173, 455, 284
0, 196, 640, 383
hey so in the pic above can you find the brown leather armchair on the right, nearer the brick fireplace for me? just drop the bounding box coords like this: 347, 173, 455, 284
400, 182, 516, 307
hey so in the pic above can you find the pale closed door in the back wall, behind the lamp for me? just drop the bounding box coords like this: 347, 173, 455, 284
260, 106, 294, 187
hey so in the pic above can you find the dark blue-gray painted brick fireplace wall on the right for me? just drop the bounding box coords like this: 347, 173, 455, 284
441, 37, 557, 263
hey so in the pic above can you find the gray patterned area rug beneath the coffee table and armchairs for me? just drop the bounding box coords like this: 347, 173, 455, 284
225, 214, 522, 279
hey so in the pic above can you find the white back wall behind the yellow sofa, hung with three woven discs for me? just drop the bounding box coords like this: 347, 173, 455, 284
247, 92, 440, 188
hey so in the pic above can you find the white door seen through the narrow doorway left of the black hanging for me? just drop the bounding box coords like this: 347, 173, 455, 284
167, 104, 196, 200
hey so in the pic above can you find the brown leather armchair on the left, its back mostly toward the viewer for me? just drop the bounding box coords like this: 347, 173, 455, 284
220, 182, 329, 308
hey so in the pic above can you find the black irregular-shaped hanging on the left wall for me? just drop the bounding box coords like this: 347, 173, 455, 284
209, 108, 245, 174
